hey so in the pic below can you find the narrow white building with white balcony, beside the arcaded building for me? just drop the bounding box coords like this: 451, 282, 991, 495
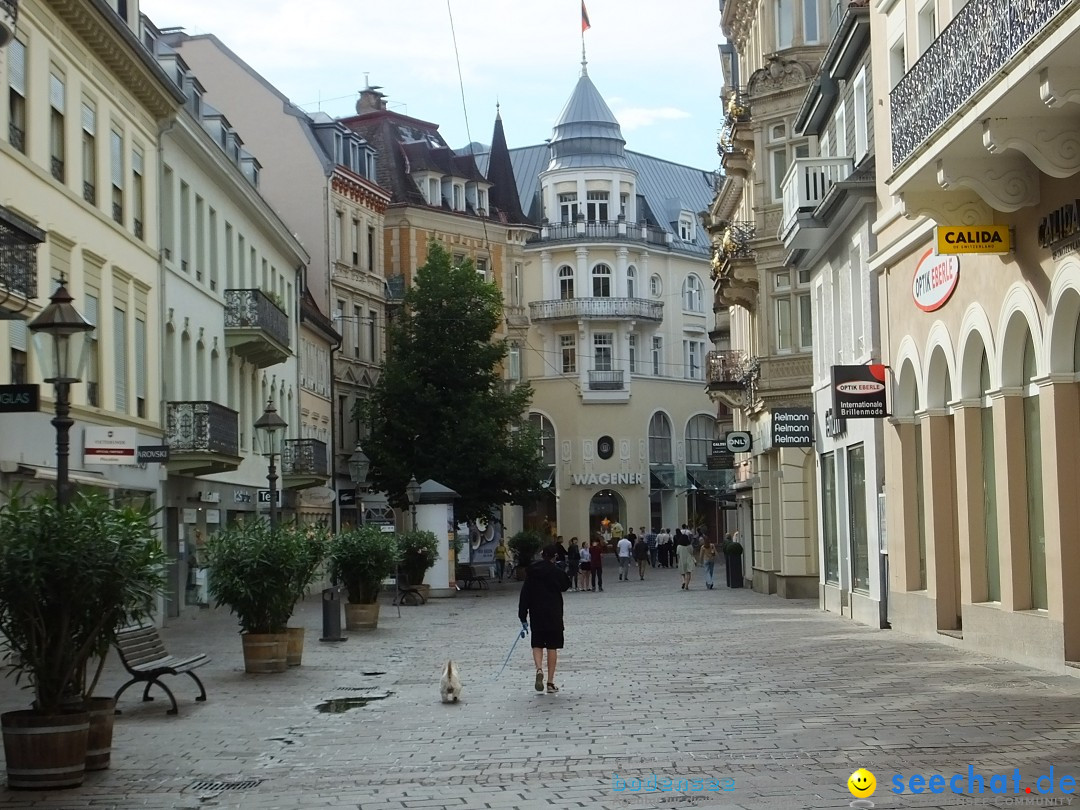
779, 2, 888, 626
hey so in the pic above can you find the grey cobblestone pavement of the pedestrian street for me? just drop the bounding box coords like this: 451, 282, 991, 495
0, 566, 1080, 810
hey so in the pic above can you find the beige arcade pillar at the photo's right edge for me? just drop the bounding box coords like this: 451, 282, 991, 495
1039, 374, 1080, 661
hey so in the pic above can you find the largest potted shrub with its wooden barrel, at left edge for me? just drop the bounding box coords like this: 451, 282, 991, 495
0, 494, 164, 788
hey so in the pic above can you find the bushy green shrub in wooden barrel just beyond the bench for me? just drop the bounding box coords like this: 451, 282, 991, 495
206, 519, 311, 674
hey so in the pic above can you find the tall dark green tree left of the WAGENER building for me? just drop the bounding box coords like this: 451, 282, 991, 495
357, 242, 541, 522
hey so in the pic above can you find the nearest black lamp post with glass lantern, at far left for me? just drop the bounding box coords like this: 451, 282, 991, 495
27, 276, 94, 507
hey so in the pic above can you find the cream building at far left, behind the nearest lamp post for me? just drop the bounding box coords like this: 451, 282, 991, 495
0, 0, 184, 516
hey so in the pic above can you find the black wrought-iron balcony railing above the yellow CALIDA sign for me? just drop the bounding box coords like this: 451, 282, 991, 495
889, 0, 1074, 168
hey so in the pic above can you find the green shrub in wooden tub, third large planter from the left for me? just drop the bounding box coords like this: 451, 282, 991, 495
327, 526, 397, 630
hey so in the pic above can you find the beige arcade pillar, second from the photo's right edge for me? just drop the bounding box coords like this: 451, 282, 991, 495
990, 388, 1023, 610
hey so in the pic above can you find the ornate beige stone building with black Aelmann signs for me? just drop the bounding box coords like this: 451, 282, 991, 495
710, 0, 831, 597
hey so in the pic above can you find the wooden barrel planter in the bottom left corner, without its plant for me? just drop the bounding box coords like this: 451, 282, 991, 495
0, 710, 90, 791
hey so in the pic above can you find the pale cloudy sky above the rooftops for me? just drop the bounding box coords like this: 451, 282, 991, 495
140, 0, 721, 170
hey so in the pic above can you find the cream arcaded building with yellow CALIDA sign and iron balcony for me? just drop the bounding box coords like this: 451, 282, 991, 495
872, 0, 1080, 672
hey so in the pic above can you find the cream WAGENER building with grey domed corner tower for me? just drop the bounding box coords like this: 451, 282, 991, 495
501, 65, 717, 540
